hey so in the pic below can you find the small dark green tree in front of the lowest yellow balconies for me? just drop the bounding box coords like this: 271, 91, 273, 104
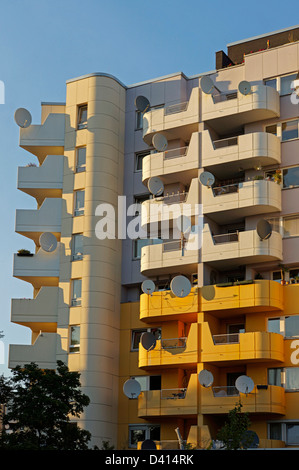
217, 403, 253, 450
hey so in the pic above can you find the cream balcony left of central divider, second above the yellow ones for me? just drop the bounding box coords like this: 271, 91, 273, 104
141, 178, 199, 228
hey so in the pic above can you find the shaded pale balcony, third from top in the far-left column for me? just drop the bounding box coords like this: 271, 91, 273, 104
15, 198, 62, 246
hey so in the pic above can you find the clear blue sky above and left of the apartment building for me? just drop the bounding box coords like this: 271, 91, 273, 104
0, 0, 299, 374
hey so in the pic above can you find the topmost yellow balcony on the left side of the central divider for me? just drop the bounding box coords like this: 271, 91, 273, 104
140, 287, 200, 323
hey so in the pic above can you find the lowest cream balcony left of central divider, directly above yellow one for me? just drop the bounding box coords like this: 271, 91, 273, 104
140, 239, 199, 276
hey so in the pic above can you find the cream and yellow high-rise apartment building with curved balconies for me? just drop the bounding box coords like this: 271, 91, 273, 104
9, 27, 299, 449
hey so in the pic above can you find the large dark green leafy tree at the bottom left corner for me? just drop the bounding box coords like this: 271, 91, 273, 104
0, 361, 91, 450
